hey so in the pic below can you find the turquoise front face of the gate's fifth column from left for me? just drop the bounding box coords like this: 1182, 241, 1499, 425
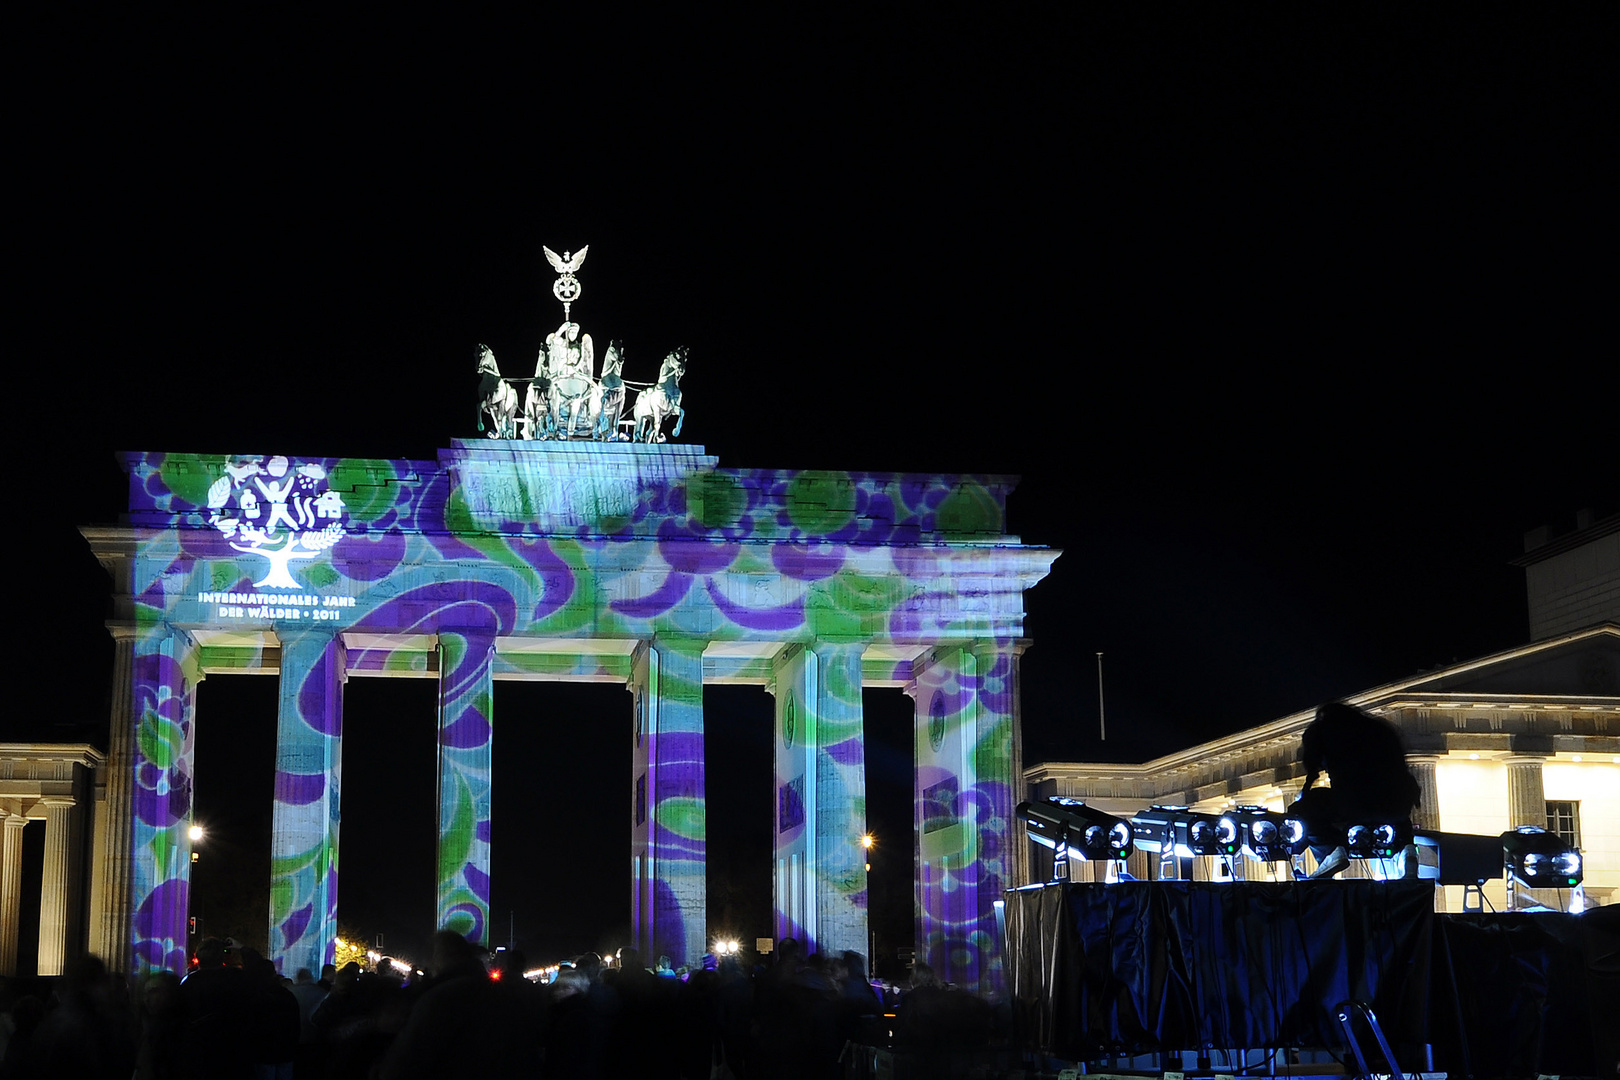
807, 641, 868, 957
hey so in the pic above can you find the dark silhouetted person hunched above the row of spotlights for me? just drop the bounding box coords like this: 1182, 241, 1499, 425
1288, 701, 1419, 878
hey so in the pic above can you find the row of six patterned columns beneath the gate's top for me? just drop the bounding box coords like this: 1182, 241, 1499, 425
91, 627, 1027, 988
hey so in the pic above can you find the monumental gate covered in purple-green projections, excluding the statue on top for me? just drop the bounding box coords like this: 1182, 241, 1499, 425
84, 440, 1058, 988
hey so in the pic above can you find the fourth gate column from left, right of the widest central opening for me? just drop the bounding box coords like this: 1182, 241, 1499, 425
630, 636, 708, 967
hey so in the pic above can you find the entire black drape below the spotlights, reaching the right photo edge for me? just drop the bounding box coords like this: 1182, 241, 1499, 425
1006, 881, 1620, 1077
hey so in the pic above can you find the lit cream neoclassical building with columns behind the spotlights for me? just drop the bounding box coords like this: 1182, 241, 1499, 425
1024, 517, 1620, 910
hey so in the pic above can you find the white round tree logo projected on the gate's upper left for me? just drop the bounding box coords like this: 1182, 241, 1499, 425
207, 455, 345, 589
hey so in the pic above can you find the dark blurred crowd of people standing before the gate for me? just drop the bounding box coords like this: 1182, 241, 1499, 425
0, 931, 998, 1080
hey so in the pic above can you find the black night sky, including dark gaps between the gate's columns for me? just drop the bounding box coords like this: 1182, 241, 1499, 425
3, 3, 1617, 959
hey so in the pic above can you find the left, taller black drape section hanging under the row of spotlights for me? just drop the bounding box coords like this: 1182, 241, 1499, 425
1008, 881, 1434, 1061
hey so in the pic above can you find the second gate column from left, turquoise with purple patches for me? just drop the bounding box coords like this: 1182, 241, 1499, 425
269, 630, 345, 976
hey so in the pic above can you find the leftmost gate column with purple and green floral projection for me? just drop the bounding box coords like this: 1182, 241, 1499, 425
130, 623, 203, 978
